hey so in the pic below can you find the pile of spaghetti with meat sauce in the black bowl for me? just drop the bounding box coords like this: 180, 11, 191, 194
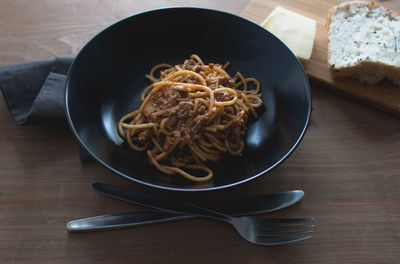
118, 55, 262, 182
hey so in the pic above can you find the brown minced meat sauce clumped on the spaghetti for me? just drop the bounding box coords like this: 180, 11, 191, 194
138, 59, 246, 166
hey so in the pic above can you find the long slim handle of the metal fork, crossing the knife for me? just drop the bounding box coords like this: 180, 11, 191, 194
92, 182, 232, 221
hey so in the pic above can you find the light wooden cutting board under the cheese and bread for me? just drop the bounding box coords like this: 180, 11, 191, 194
242, 0, 400, 117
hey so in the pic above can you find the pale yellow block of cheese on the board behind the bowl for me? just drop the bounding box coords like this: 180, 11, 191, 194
261, 6, 317, 61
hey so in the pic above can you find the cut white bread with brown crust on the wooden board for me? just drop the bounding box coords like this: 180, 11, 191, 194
326, 1, 400, 86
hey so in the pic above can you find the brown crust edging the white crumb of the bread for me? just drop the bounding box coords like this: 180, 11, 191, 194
325, 1, 400, 86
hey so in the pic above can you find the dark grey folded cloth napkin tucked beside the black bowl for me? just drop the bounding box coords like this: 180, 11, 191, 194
0, 58, 90, 161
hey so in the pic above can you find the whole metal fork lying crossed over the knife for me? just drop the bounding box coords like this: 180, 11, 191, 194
92, 183, 314, 245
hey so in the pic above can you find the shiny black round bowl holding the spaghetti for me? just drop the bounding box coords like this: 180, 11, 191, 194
65, 8, 311, 191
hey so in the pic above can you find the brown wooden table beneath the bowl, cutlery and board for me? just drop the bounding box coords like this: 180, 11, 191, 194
0, 0, 400, 263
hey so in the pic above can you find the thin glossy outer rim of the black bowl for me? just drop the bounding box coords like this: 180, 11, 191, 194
64, 6, 312, 192
